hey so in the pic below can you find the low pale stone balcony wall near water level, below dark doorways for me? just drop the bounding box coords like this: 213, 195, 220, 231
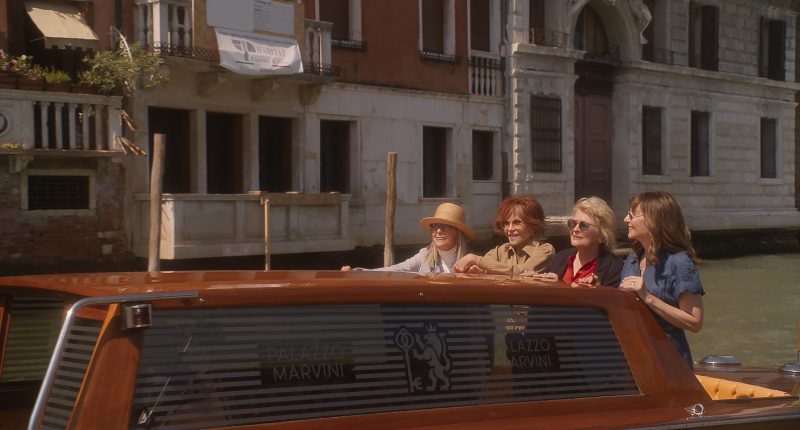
134, 192, 354, 260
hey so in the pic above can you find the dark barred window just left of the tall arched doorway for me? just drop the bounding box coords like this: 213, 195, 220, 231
531, 96, 561, 172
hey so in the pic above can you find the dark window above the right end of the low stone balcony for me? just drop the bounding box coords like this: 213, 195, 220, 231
319, 120, 350, 194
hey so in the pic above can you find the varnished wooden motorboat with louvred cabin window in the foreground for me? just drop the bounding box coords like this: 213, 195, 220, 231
0, 271, 800, 430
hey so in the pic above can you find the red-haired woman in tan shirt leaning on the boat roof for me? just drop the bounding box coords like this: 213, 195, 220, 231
455, 196, 555, 275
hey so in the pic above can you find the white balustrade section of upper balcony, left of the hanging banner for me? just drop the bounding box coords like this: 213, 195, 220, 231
135, 0, 193, 56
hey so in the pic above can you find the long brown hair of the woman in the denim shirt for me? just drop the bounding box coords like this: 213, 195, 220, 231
629, 191, 699, 263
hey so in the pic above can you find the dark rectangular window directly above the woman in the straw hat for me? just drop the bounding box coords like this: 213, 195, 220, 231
422, 127, 447, 197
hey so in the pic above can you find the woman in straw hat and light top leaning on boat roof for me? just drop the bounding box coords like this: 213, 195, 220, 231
342, 203, 475, 273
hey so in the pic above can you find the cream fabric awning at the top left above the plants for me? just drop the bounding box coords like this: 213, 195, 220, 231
25, 0, 97, 49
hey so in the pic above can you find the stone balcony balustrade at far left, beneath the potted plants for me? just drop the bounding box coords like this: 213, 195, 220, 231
0, 86, 122, 151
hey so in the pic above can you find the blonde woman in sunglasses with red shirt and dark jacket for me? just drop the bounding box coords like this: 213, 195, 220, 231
522, 197, 622, 287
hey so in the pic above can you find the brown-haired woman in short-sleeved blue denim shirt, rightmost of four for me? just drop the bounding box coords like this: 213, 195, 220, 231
620, 191, 705, 368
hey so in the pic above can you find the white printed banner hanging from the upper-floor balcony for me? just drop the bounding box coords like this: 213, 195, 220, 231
215, 28, 303, 75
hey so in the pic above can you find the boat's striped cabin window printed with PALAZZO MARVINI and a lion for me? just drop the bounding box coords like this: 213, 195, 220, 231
129, 304, 640, 429
